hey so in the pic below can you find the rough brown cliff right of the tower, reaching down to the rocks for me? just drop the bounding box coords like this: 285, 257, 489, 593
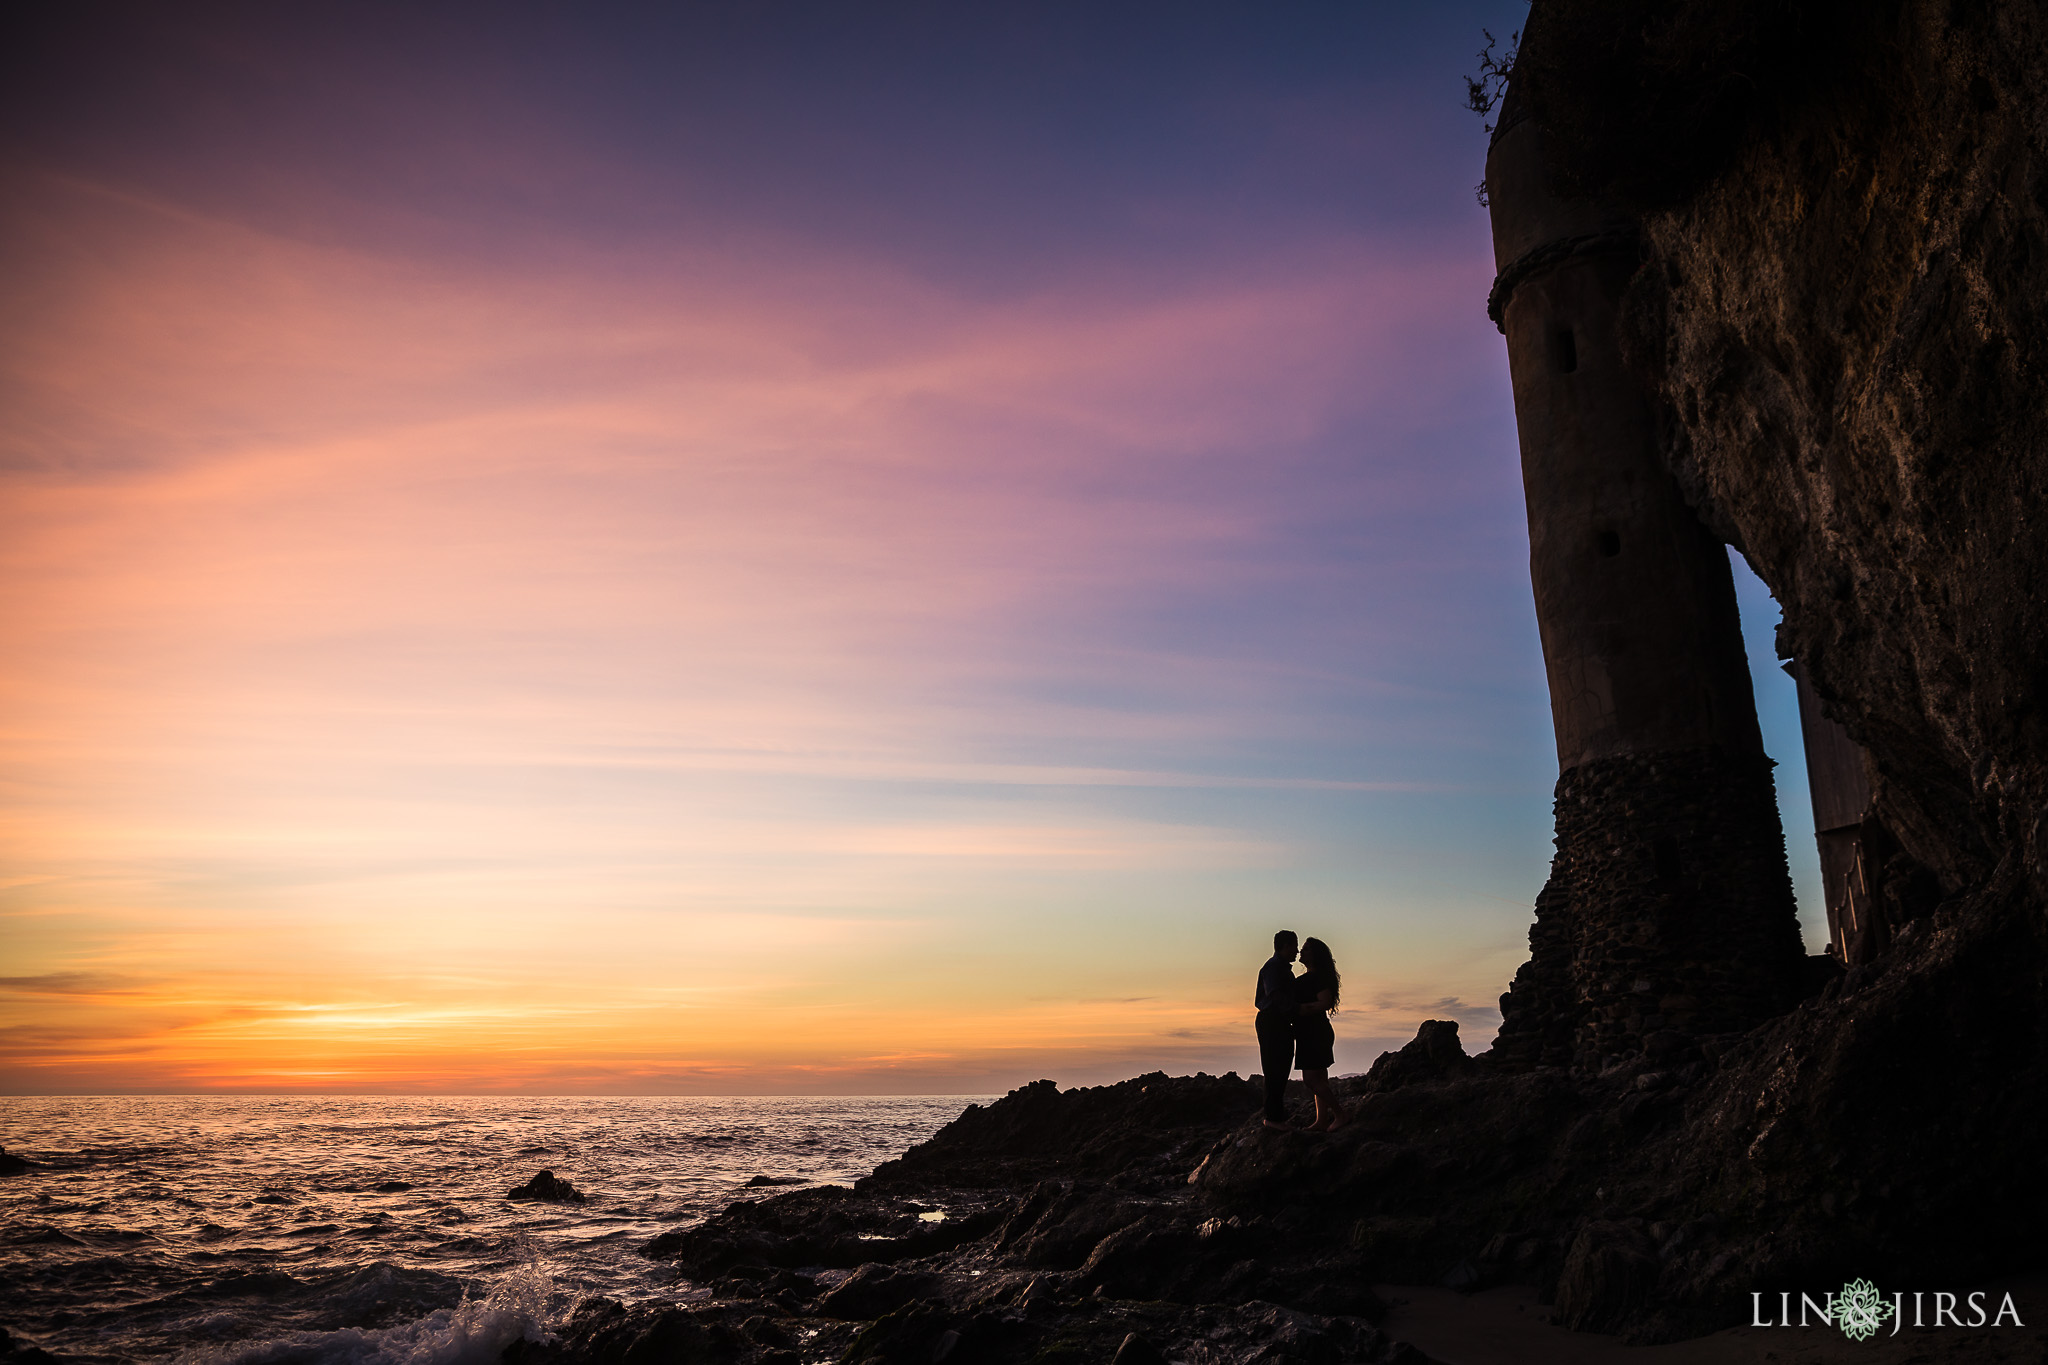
1490, 0, 2048, 1314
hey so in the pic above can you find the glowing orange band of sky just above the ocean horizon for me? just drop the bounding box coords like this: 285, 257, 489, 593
0, 982, 1507, 1095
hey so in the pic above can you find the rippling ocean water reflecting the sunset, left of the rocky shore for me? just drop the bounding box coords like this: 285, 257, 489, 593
0, 1095, 989, 1365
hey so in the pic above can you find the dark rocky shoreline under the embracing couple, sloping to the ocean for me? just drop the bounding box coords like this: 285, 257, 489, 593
506, 1021, 1753, 1365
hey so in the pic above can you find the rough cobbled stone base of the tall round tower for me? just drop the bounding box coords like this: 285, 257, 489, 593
1493, 749, 1804, 1068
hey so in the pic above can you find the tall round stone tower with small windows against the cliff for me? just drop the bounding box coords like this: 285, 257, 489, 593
1487, 100, 1804, 1068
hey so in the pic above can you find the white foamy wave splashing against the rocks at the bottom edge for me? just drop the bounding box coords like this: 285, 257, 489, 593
180, 1259, 557, 1365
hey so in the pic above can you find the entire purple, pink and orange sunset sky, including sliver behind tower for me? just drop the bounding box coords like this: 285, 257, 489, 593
0, 0, 1821, 1093
